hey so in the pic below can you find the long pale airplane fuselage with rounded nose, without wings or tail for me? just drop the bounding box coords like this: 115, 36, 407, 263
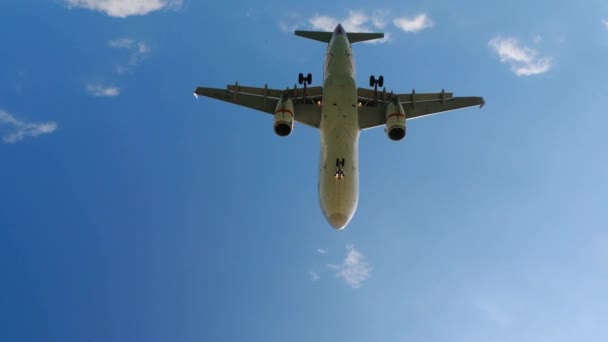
319, 29, 360, 229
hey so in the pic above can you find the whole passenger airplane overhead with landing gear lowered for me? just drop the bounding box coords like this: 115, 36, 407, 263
194, 24, 485, 230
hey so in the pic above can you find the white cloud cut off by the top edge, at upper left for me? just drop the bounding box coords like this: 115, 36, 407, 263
65, 0, 183, 18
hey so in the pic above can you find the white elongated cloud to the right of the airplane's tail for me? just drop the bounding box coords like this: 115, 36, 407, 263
488, 37, 553, 76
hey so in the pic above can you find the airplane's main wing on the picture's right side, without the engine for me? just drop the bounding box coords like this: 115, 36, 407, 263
357, 88, 485, 129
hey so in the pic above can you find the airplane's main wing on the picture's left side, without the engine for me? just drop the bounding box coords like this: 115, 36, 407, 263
194, 83, 323, 128
